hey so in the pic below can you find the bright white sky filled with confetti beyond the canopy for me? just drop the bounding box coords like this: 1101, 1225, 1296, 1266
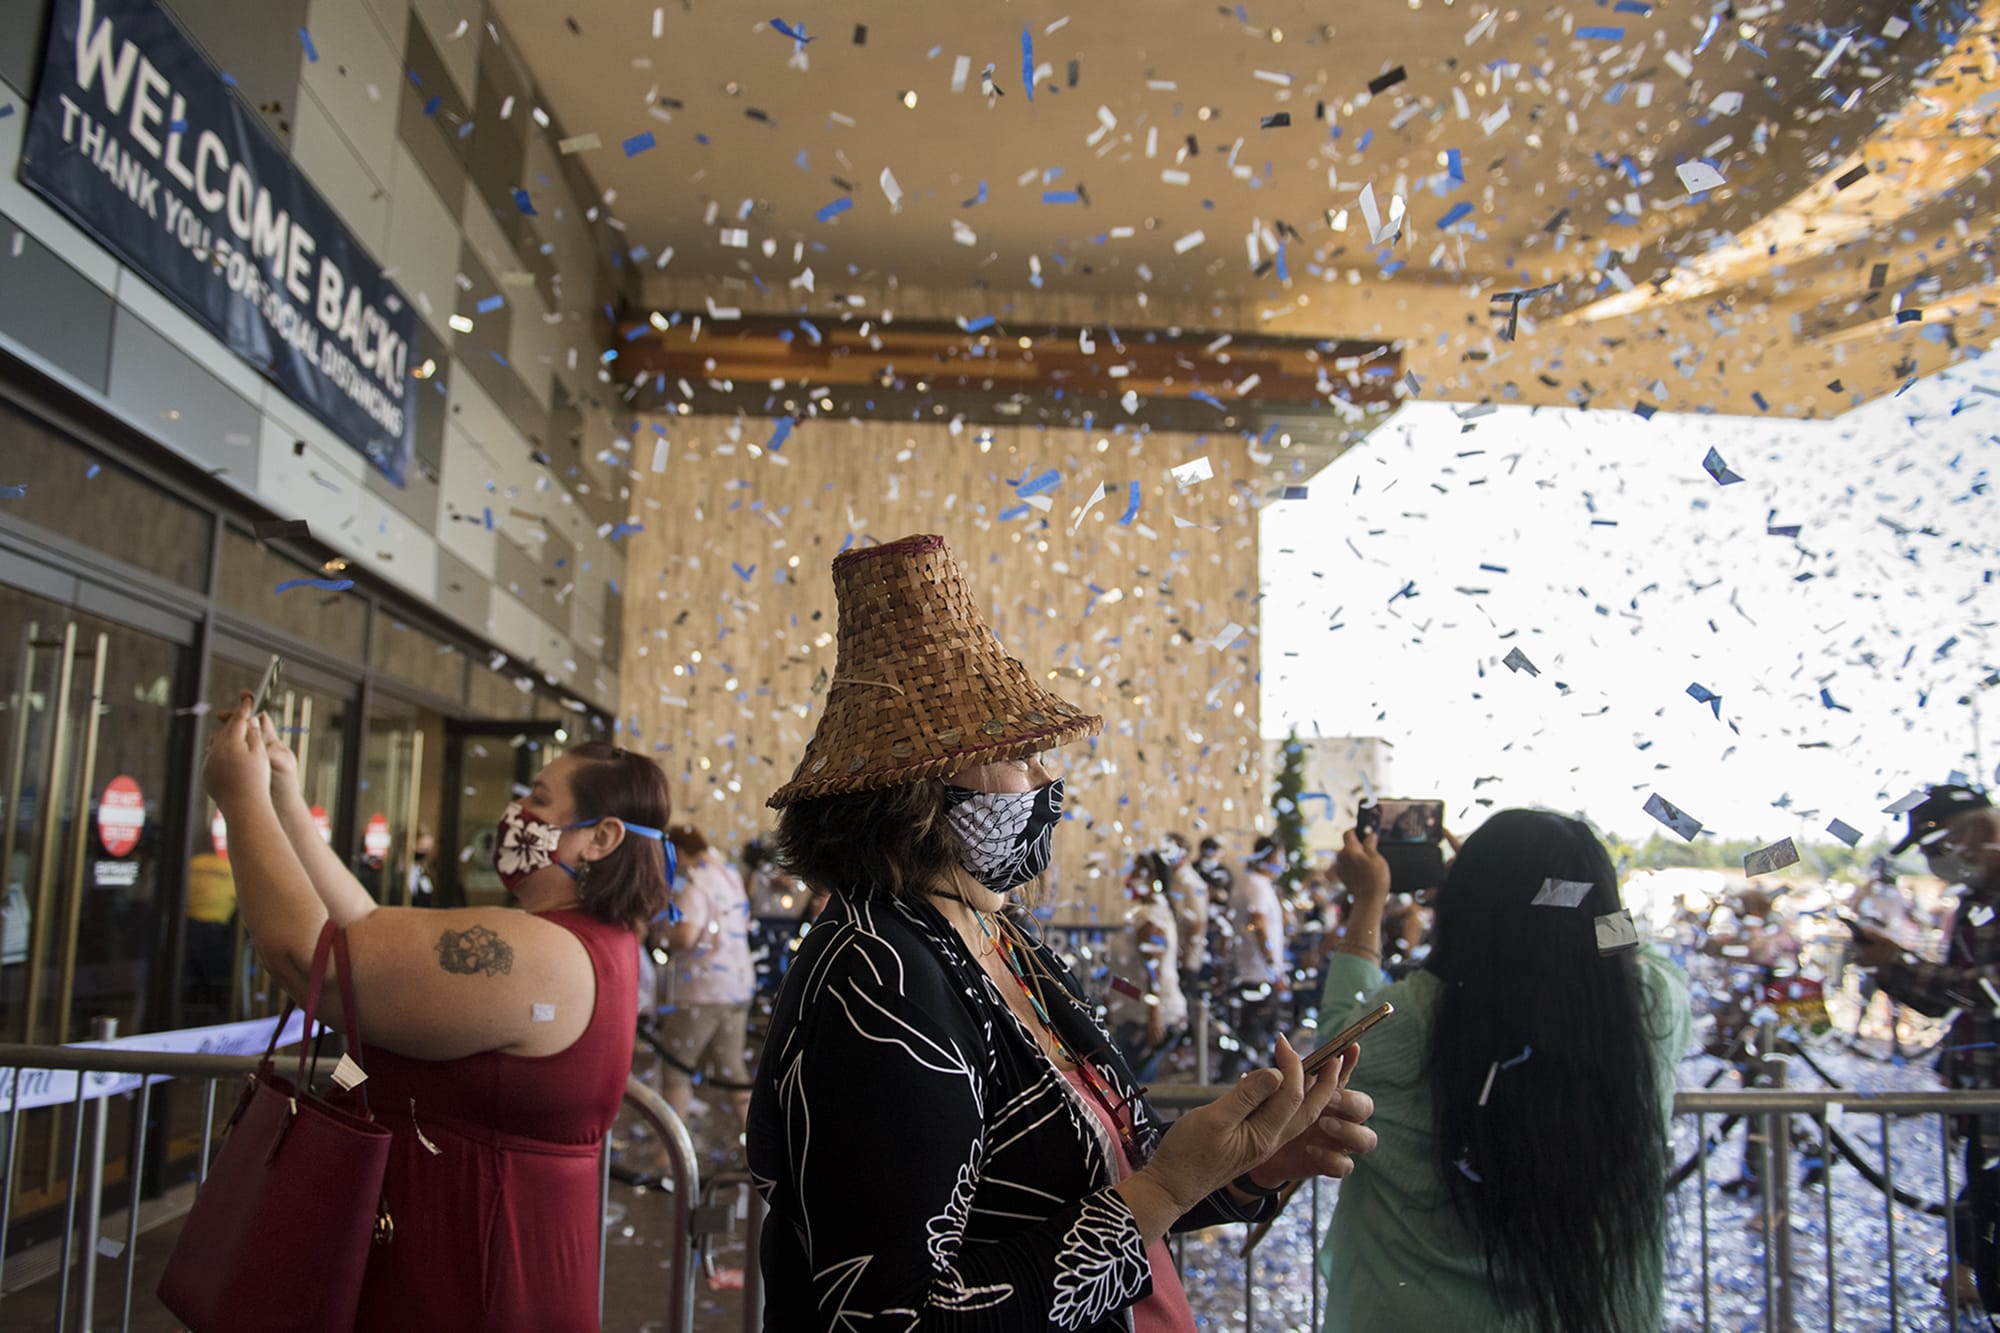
1262, 358, 2000, 843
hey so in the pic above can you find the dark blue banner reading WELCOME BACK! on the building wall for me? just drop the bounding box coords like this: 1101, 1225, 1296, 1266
20, 0, 416, 486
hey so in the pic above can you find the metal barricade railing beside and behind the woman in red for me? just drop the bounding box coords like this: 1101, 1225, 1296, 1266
0, 1043, 700, 1333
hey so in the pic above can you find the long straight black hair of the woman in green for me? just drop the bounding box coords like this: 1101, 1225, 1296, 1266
1426, 811, 1668, 1333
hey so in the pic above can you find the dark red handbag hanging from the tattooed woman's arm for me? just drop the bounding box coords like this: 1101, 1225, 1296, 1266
160, 921, 396, 1333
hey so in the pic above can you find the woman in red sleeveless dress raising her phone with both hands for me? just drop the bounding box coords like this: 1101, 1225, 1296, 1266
202, 695, 672, 1333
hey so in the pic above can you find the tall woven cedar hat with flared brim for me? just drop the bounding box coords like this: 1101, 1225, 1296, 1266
766, 536, 1104, 809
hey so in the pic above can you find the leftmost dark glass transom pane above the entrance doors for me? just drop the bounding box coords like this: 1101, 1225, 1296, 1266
0, 392, 214, 590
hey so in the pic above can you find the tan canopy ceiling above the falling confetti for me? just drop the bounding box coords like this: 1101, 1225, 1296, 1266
494, 0, 2000, 426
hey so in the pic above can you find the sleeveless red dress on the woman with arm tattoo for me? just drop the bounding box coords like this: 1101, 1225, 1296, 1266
356, 911, 638, 1333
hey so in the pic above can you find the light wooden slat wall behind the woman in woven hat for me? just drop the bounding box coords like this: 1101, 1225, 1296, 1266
620, 416, 1268, 921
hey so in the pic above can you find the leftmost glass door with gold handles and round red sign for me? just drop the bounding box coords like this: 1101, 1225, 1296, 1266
0, 584, 192, 1217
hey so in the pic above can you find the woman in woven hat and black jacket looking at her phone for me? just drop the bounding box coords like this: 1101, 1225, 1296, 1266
750, 536, 1374, 1333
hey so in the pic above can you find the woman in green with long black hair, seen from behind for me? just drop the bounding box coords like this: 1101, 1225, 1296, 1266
1320, 811, 1690, 1333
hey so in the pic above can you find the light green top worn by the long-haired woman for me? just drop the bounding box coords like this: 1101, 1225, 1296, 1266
1318, 947, 1692, 1333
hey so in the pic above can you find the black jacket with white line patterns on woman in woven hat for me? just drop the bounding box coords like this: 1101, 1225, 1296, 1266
750, 880, 1274, 1333
